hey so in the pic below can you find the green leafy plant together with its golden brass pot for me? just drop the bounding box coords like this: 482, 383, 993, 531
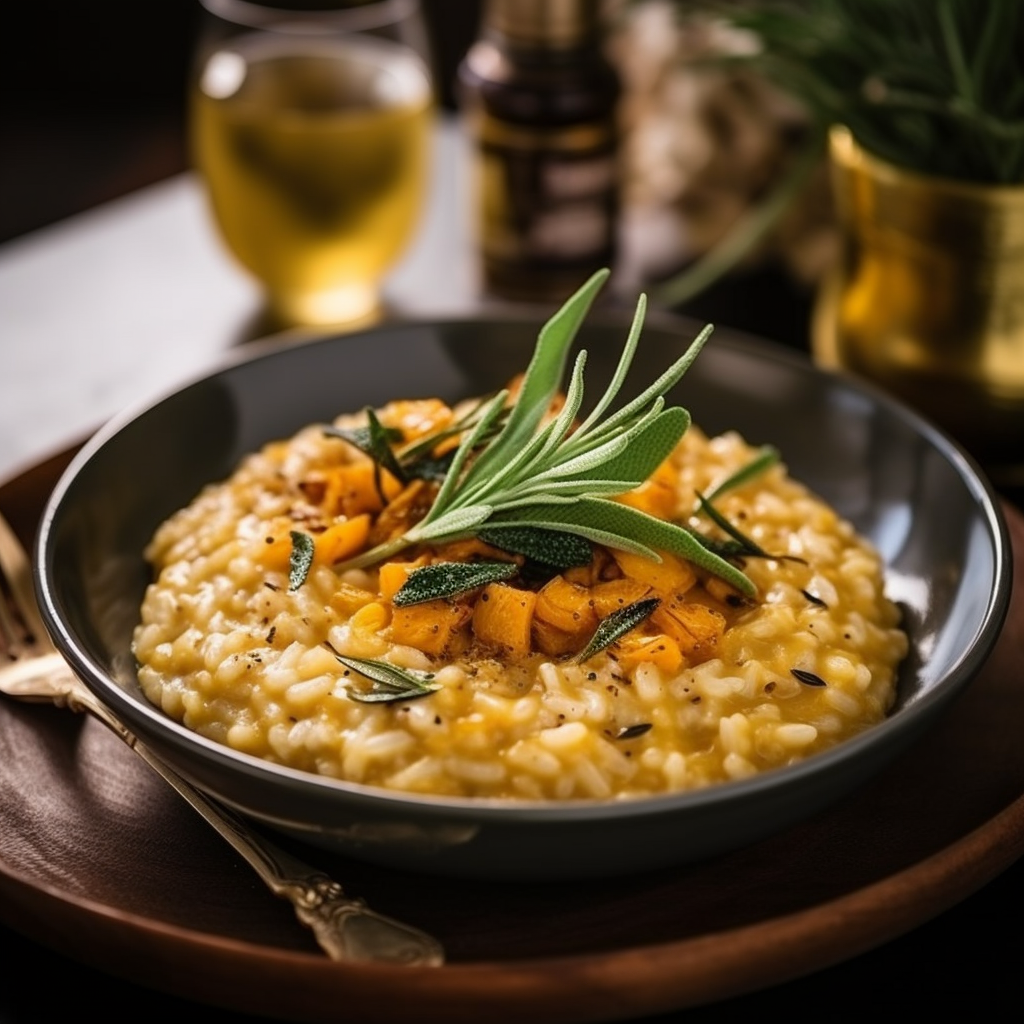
638, 0, 1024, 486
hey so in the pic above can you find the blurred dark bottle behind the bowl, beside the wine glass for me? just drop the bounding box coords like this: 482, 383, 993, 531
459, 0, 622, 301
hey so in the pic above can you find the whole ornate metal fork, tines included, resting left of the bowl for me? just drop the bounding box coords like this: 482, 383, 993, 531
0, 515, 444, 967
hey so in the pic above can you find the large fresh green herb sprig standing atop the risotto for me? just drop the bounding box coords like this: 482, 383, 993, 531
331, 270, 755, 596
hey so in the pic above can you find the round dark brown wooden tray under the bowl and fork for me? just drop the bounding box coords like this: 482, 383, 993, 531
0, 455, 1024, 1024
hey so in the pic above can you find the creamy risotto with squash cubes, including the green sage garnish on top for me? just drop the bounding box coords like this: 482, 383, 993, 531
133, 271, 907, 801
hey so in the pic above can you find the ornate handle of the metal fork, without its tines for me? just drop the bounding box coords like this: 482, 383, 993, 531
0, 653, 444, 967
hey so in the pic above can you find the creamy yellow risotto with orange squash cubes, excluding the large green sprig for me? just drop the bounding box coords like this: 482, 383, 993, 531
134, 391, 907, 800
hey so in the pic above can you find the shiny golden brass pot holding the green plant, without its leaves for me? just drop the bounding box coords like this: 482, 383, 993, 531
812, 121, 1024, 487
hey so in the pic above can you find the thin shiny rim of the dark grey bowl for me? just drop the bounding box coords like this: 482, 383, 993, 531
32, 307, 1013, 822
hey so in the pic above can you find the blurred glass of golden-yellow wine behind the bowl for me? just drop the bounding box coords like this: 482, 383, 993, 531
189, 0, 436, 327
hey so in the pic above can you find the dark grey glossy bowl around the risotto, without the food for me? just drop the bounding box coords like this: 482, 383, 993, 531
36, 313, 1012, 880
